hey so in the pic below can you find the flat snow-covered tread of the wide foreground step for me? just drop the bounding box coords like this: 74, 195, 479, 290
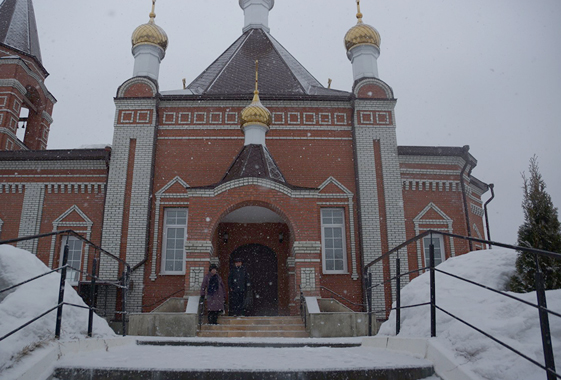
57, 340, 432, 371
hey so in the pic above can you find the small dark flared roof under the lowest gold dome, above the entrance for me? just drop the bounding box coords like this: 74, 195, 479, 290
220, 144, 286, 184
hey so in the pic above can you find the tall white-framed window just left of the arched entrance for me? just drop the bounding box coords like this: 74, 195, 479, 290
162, 208, 187, 274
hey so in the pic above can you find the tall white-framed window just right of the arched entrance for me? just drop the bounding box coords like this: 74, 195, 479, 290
321, 208, 347, 273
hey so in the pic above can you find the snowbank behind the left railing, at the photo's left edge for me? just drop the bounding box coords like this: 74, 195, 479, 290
0, 245, 115, 372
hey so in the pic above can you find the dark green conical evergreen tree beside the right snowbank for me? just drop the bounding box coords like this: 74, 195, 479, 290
510, 156, 561, 292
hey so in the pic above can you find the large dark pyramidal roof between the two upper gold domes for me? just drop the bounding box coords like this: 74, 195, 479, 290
187, 29, 349, 98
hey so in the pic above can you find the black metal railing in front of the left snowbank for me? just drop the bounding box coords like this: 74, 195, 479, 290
0, 230, 131, 342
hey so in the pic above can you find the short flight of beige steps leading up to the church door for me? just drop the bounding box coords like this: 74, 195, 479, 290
197, 316, 309, 338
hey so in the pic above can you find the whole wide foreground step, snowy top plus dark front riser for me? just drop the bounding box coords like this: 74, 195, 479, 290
50, 338, 434, 380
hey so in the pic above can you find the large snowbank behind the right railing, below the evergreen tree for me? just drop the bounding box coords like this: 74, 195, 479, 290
379, 249, 561, 380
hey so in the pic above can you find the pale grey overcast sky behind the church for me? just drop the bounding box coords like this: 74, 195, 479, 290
34, 0, 561, 243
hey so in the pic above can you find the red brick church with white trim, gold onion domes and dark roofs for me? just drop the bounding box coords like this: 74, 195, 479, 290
0, 0, 488, 315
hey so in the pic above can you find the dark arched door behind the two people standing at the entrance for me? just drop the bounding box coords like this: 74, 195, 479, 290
230, 244, 279, 316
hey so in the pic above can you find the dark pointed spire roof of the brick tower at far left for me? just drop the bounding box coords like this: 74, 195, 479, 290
0, 0, 41, 62
